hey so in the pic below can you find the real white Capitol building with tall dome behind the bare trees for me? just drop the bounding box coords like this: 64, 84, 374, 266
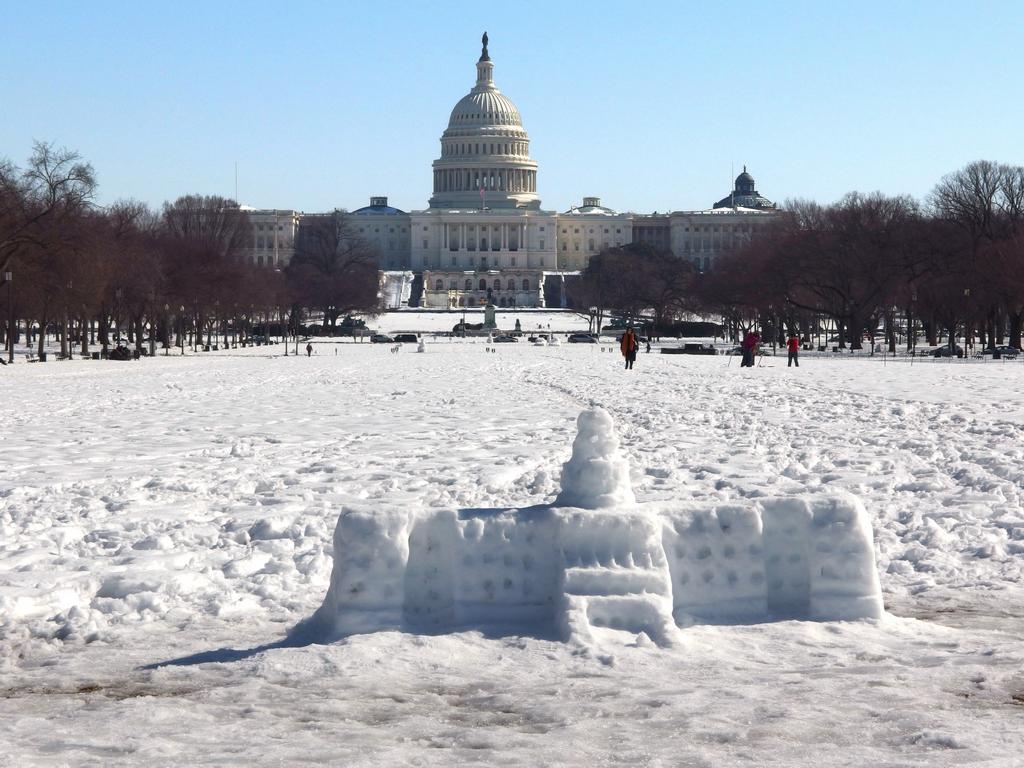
247, 34, 776, 308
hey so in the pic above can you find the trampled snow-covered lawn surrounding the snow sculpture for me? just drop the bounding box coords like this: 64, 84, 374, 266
0, 346, 1024, 766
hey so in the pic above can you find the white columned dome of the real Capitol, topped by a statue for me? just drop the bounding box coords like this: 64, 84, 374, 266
430, 33, 541, 210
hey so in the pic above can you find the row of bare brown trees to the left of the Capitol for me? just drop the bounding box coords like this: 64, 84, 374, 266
0, 143, 378, 355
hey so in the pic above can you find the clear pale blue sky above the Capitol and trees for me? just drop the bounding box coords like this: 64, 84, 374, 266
0, 0, 1024, 212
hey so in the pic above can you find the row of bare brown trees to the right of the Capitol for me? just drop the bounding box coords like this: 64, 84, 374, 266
569, 161, 1024, 352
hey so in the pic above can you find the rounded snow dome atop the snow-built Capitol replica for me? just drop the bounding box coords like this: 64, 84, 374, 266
555, 408, 636, 509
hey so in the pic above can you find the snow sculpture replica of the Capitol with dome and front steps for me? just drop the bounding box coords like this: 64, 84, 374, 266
303, 409, 883, 645
